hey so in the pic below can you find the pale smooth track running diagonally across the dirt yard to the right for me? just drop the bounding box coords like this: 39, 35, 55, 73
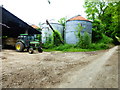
57, 46, 118, 88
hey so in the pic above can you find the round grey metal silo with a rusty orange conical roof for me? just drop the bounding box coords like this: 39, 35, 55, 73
65, 15, 92, 44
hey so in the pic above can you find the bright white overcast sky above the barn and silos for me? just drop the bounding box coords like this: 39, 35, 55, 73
0, 0, 86, 25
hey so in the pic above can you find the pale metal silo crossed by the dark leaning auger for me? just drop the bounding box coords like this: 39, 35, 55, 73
42, 23, 63, 43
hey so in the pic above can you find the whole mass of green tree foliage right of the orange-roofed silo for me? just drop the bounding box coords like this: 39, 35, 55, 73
84, 0, 120, 44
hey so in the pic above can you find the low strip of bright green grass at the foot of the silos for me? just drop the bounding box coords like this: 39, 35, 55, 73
43, 43, 109, 52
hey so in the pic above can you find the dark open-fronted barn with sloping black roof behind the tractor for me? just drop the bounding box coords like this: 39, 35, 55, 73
0, 7, 41, 45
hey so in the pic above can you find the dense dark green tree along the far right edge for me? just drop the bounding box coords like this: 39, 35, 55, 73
101, 2, 120, 44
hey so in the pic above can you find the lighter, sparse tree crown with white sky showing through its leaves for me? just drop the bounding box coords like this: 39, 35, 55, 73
84, 0, 108, 20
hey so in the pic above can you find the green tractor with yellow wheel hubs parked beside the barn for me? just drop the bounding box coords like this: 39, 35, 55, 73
15, 34, 43, 54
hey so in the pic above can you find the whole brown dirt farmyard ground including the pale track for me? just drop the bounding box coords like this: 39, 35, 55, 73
0, 46, 118, 88
